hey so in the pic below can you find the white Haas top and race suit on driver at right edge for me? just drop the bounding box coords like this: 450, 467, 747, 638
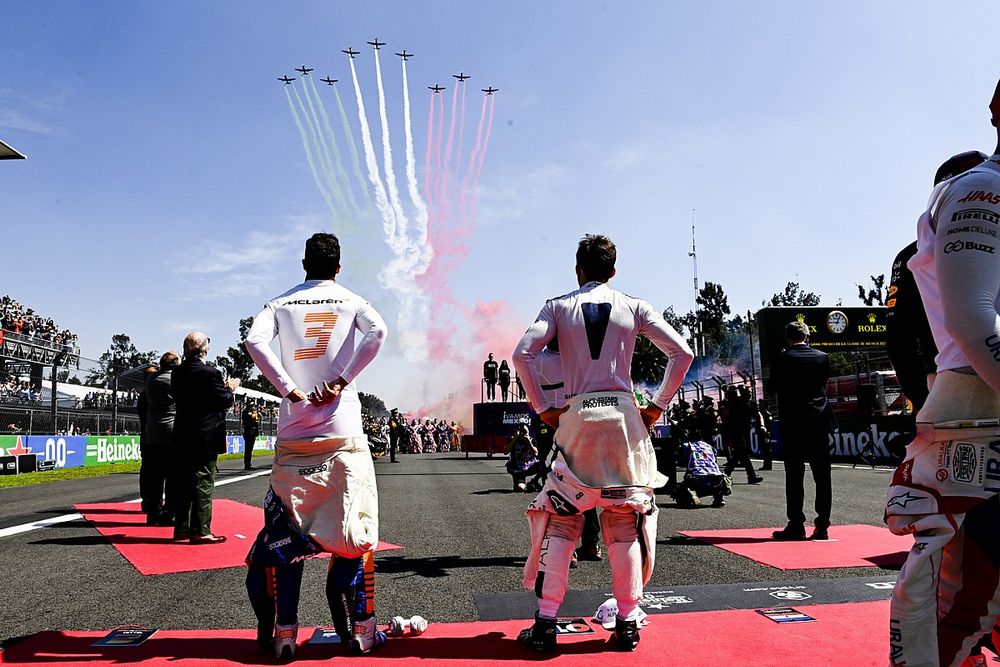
885, 155, 1000, 667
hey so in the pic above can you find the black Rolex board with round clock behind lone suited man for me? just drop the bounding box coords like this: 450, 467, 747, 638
757, 306, 887, 366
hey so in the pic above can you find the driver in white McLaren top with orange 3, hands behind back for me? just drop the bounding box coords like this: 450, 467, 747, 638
246, 234, 386, 659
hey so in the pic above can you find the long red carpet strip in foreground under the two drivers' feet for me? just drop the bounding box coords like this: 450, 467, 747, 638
0, 601, 889, 667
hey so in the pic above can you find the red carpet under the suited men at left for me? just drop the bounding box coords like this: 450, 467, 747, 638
76, 499, 402, 575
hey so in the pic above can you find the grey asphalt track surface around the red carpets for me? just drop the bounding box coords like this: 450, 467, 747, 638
0, 453, 896, 644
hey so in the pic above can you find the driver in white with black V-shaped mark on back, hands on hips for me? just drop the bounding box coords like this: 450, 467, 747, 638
514, 235, 692, 651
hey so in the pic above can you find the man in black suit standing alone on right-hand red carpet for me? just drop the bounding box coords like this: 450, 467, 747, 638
770, 322, 833, 540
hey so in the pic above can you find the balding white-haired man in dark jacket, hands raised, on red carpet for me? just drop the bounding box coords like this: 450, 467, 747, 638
170, 331, 240, 544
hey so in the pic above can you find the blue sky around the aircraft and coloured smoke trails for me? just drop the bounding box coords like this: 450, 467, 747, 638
0, 1, 1000, 418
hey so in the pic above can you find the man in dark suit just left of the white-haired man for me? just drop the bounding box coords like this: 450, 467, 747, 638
139, 352, 181, 526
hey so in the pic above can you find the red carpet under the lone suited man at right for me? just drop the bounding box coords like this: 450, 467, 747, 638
680, 525, 913, 570
